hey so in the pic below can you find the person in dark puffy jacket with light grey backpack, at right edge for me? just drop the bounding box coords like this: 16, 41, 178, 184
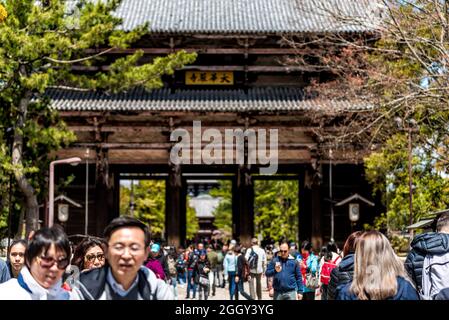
405, 212, 449, 300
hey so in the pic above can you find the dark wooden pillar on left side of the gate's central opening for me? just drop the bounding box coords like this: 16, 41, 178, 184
165, 165, 186, 247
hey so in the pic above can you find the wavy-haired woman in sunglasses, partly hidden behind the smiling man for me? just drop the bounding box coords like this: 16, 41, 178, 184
72, 237, 106, 271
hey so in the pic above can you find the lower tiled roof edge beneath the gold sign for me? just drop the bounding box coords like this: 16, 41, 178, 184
48, 88, 372, 112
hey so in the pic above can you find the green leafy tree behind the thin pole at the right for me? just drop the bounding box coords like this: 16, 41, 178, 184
365, 133, 449, 230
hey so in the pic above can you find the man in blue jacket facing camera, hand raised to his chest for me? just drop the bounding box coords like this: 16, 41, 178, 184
265, 242, 304, 300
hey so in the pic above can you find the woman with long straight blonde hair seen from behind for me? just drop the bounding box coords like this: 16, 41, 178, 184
336, 231, 419, 300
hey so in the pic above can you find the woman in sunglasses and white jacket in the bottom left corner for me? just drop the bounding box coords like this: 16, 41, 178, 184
0, 226, 74, 300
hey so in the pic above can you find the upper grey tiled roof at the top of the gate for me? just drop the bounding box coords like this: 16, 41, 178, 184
109, 0, 383, 34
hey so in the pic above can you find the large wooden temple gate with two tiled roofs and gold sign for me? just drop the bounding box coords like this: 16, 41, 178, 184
49, 0, 379, 246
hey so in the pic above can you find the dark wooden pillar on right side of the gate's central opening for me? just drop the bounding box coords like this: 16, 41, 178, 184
233, 166, 254, 247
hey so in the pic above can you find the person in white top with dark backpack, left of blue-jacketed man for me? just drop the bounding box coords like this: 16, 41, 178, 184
245, 238, 267, 300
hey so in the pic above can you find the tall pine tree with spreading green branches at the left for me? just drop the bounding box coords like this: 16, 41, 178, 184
0, 0, 196, 238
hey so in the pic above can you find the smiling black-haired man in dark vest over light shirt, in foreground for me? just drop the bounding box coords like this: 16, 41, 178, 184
75, 217, 174, 300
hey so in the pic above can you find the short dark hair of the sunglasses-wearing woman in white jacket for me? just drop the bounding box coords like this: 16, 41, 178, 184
25, 225, 72, 268
